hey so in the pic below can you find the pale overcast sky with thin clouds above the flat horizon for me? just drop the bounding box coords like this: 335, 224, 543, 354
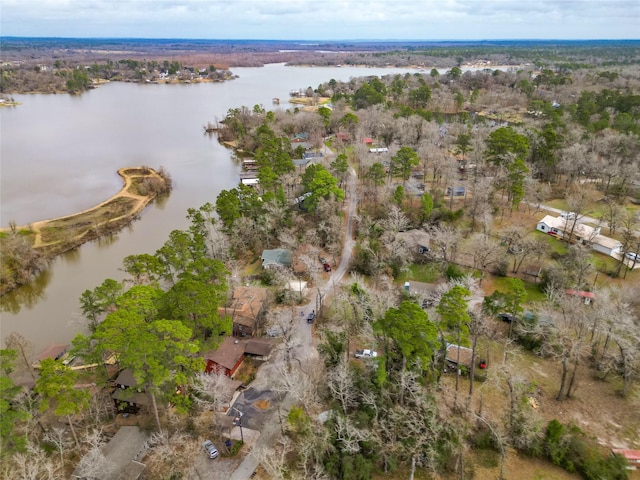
0, 0, 640, 40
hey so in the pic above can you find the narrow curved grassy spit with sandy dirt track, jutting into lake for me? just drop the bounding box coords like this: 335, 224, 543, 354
0, 166, 172, 295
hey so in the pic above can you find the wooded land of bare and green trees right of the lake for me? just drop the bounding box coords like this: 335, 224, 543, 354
0, 42, 640, 480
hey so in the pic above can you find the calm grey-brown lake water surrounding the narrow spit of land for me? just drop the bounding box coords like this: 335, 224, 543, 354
0, 64, 415, 353
